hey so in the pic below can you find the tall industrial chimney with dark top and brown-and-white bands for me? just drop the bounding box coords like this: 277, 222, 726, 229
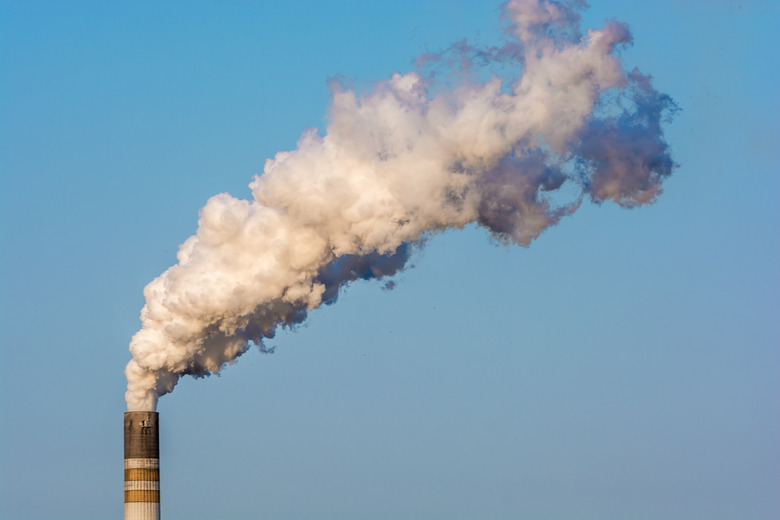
125, 412, 160, 520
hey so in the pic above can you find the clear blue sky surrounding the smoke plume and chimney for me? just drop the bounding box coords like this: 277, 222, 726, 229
0, 0, 780, 520
